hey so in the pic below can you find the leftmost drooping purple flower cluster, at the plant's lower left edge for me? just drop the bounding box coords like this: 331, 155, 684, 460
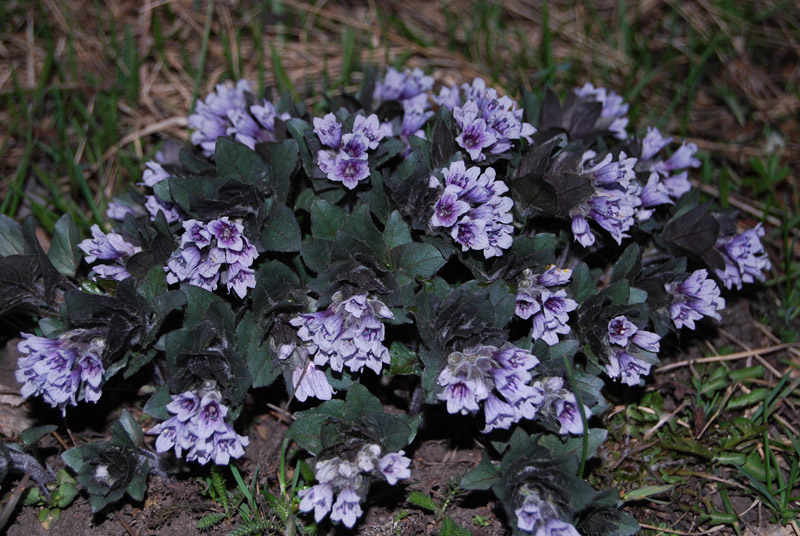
15, 330, 105, 414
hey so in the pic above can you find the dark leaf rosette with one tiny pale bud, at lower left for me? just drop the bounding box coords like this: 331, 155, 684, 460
61, 410, 167, 513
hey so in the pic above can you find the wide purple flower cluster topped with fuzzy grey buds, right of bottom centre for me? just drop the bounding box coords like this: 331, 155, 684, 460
437, 345, 544, 433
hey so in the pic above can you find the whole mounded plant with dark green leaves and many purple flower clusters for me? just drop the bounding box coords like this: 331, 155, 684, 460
0, 69, 770, 536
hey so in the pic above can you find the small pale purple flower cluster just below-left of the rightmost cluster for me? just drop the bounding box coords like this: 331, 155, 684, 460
665, 270, 725, 329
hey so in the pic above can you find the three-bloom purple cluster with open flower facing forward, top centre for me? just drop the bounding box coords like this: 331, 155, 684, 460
314, 114, 386, 190
